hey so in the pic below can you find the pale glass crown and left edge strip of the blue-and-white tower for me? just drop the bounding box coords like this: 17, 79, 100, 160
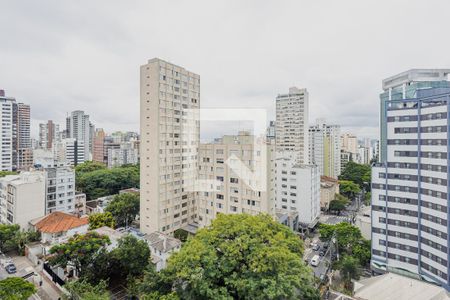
380, 69, 450, 162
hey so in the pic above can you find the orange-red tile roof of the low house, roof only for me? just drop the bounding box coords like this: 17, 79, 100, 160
35, 211, 89, 233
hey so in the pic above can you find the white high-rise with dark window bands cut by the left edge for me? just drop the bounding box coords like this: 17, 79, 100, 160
0, 90, 16, 171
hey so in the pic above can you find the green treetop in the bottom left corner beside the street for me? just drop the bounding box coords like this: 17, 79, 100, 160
0, 277, 37, 300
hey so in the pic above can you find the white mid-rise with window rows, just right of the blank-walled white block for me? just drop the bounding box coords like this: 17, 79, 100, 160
44, 166, 76, 214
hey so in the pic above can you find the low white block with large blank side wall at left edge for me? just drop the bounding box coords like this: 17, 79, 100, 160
0, 171, 45, 229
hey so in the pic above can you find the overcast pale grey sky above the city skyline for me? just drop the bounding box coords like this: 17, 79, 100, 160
0, 0, 450, 138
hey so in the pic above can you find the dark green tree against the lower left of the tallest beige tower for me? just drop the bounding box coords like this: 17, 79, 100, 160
105, 193, 140, 227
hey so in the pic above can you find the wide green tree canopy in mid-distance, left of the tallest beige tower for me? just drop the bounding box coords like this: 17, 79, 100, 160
76, 165, 140, 200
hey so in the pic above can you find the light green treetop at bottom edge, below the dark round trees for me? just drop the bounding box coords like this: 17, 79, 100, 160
64, 280, 110, 300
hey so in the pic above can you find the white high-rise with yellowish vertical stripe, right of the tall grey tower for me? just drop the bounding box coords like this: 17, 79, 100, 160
309, 120, 341, 178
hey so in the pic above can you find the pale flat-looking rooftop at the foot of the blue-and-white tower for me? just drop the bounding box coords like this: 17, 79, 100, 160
355, 273, 450, 300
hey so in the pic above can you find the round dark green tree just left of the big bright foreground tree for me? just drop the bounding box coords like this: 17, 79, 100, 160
111, 234, 150, 278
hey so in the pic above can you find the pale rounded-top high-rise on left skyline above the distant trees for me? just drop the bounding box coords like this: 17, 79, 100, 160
66, 110, 93, 161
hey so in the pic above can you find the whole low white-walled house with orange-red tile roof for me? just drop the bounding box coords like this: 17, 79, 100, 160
29, 211, 89, 245
